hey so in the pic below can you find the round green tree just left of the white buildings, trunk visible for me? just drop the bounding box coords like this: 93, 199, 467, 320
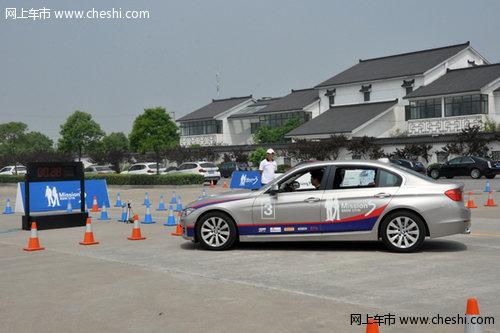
129, 107, 180, 172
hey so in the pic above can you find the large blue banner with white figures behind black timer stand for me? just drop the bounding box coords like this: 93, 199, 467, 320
16, 179, 109, 212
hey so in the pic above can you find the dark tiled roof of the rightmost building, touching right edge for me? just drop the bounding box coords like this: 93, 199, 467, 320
405, 64, 500, 98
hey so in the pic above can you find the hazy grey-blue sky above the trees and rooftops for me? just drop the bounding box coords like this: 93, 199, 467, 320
0, 0, 500, 141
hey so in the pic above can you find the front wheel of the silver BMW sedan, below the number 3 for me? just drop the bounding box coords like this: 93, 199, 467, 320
196, 212, 236, 250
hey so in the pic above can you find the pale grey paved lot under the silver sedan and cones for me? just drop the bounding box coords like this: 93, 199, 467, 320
0, 178, 500, 333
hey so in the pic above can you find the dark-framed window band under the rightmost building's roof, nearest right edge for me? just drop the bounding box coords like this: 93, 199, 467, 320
445, 95, 488, 117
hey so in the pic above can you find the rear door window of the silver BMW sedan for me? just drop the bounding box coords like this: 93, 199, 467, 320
333, 167, 377, 190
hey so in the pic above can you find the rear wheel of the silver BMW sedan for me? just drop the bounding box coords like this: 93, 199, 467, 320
380, 211, 425, 252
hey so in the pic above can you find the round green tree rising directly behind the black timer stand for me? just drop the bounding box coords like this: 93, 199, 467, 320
58, 111, 104, 161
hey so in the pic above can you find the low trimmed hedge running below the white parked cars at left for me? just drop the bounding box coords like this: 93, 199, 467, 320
85, 174, 205, 185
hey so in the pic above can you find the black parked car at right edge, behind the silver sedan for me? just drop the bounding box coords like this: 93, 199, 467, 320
427, 156, 500, 179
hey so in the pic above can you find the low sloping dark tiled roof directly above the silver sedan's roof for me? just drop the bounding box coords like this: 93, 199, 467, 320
286, 99, 398, 137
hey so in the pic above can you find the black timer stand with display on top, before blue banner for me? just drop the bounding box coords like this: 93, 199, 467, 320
22, 162, 89, 230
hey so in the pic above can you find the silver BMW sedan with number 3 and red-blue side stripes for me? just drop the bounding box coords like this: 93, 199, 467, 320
179, 160, 471, 252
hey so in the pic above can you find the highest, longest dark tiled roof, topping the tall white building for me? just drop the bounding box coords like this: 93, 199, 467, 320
316, 42, 469, 88
